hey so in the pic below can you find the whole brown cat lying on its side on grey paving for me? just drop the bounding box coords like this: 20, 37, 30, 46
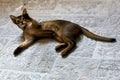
10, 7, 116, 57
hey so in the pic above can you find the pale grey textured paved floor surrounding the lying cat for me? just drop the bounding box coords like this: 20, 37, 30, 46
0, 0, 120, 80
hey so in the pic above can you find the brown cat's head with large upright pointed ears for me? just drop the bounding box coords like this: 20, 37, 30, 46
10, 8, 31, 29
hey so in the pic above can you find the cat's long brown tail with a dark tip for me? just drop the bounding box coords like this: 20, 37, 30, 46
81, 27, 116, 42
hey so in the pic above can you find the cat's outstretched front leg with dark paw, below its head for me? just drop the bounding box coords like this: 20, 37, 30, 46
14, 39, 35, 57
